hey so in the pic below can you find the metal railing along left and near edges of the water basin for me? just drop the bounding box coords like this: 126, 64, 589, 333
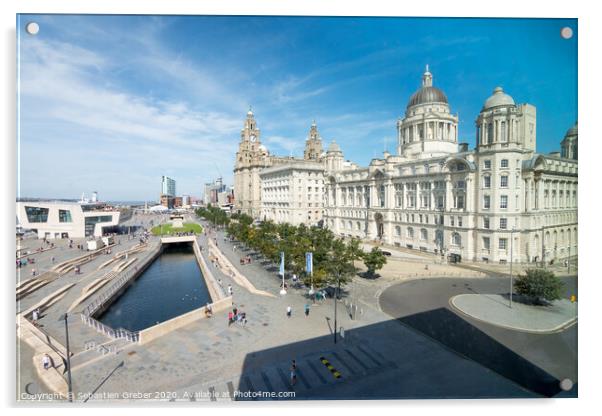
81, 242, 161, 342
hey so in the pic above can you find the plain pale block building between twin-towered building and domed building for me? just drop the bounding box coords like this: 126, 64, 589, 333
259, 161, 324, 225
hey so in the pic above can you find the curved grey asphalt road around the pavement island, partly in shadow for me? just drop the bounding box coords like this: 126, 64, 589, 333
379, 277, 577, 397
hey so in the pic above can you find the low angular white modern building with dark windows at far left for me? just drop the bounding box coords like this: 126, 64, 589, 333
17, 201, 119, 239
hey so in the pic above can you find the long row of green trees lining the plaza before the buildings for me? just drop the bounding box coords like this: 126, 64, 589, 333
197, 206, 387, 287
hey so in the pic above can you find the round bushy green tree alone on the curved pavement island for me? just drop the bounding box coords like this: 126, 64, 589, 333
514, 269, 564, 304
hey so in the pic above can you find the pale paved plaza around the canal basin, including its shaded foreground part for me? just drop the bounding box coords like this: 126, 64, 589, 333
19, 217, 576, 401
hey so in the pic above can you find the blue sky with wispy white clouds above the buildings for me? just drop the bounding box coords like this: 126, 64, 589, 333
17, 15, 577, 201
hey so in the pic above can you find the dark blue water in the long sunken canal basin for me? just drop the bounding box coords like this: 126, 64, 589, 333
99, 244, 211, 331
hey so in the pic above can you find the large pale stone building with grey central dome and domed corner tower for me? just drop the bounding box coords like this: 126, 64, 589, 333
323, 67, 578, 262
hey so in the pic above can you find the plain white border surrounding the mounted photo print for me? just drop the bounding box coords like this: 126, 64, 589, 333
0, 0, 602, 416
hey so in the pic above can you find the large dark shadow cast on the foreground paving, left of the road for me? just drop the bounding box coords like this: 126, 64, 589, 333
232, 314, 540, 401
